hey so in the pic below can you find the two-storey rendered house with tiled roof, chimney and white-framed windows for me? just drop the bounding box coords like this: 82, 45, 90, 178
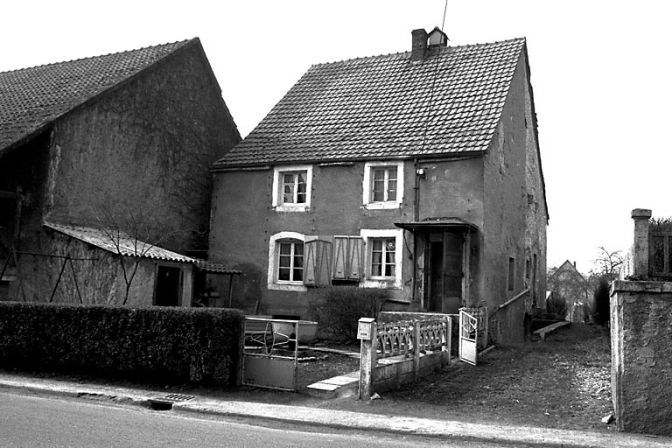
210, 29, 548, 341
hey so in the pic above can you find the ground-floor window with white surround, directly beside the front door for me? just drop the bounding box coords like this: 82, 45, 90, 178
361, 229, 404, 288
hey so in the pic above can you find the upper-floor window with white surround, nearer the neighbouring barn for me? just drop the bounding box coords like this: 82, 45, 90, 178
273, 165, 313, 212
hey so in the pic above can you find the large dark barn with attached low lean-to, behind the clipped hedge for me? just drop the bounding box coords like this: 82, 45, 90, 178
0, 39, 240, 305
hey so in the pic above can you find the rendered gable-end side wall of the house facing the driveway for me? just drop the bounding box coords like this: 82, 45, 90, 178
482, 51, 531, 342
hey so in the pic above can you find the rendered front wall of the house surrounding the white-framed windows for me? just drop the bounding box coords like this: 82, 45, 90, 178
210, 158, 483, 318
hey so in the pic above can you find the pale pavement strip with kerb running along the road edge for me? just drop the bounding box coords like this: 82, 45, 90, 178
0, 379, 672, 448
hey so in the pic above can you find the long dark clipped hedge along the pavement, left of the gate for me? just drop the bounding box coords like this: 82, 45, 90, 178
0, 302, 244, 385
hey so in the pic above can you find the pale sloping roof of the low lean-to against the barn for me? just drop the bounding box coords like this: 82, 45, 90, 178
44, 223, 197, 263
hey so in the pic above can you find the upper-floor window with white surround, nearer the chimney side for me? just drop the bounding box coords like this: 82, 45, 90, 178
362, 162, 404, 209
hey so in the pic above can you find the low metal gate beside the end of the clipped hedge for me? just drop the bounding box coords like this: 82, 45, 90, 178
242, 317, 299, 392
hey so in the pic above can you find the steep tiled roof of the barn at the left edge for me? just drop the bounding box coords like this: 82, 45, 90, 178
0, 39, 197, 155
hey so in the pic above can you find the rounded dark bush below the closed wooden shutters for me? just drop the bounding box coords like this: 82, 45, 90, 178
309, 286, 389, 342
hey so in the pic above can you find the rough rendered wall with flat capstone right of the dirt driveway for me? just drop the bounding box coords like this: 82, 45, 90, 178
611, 281, 672, 436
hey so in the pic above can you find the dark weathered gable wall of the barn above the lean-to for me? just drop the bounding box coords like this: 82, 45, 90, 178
45, 44, 240, 257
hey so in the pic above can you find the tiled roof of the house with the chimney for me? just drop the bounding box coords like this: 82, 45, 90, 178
215, 38, 525, 168
